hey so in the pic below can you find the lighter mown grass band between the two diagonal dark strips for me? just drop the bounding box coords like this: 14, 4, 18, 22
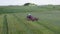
12, 14, 52, 34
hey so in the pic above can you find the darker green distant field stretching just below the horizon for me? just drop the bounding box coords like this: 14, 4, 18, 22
0, 5, 60, 14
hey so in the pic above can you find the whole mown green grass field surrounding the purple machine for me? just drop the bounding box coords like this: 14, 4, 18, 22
0, 7, 60, 34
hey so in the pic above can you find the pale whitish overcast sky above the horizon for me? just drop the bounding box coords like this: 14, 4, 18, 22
0, 0, 60, 5
